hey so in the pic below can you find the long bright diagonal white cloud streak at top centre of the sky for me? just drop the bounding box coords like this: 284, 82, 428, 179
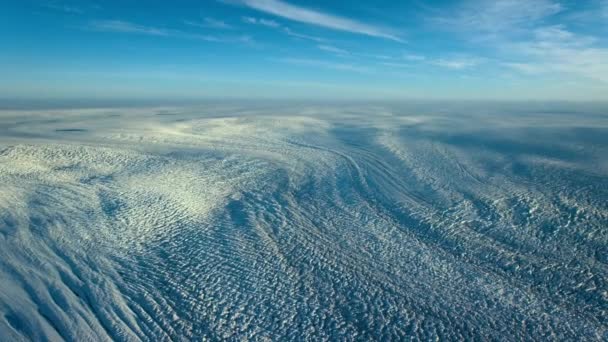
230, 0, 402, 42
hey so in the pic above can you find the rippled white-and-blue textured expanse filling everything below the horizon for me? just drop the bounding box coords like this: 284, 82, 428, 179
0, 102, 608, 341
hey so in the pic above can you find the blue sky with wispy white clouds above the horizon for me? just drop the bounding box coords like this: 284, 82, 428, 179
0, 0, 608, 100
